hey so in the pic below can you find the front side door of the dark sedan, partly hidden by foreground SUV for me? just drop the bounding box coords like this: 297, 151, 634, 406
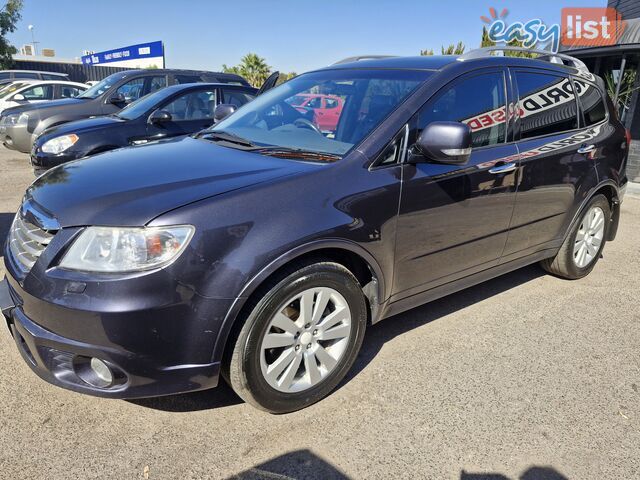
147, 87, 217, 140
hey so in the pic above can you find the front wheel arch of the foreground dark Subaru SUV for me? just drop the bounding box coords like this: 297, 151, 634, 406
212, 239, 385, 362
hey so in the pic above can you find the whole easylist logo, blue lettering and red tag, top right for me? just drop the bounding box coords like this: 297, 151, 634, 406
480, 8, 625, 53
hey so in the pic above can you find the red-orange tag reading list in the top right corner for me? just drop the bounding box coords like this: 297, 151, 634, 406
562, 8, 625, 47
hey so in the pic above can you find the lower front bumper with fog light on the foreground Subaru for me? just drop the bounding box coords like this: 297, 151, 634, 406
0, 277, 225, 398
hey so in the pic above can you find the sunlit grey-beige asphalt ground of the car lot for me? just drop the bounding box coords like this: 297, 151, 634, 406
0, 147, 640, 480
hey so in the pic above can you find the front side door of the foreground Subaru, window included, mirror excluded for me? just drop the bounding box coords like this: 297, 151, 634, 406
394, 69, 518, 299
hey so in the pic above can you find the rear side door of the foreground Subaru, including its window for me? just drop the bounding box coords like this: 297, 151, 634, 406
502, 68, 595, 262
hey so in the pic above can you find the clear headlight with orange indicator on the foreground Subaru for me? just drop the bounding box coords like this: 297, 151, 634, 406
60, 225, 195, 272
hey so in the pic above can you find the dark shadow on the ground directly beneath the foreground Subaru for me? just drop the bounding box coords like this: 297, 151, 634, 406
131, 265, 545, 412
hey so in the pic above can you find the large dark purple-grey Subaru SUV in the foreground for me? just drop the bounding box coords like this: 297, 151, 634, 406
0, 50, 627, 413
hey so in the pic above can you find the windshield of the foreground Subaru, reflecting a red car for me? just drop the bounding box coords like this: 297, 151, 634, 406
210, 69, 431, 156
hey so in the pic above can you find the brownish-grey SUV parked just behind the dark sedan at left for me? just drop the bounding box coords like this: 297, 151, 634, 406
0, 69, 250, 153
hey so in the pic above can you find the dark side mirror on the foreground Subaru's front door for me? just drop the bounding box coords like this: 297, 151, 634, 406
409, 122, 472, 165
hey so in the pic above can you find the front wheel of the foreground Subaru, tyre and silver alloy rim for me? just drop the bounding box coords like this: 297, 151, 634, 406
223, 261, 367, 413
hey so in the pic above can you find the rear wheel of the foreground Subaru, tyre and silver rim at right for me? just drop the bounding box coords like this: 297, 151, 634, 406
540, 194, 611, 280
